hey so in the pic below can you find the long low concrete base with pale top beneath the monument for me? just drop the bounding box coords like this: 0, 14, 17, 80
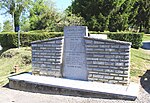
9, 73, 139, 100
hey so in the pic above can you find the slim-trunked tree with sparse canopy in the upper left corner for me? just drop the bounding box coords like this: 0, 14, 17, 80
0, 0, 32, 31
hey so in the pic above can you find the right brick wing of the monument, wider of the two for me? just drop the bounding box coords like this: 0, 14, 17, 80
85, 37, 131, 84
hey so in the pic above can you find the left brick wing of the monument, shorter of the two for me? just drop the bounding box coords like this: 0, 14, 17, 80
31, 37, 63, 77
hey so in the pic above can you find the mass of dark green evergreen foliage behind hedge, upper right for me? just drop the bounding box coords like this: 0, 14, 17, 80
68, 0, 150, 33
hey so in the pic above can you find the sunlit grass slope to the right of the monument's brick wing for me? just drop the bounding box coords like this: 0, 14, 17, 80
130, 48, 150, 81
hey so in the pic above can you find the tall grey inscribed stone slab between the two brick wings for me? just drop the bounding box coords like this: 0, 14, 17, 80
63, 26, 88, 80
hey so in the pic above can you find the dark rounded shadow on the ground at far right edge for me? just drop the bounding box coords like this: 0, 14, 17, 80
140, 70, 150, 94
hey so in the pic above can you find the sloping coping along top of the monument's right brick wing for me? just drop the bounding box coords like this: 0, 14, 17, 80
84, 36, 132, 45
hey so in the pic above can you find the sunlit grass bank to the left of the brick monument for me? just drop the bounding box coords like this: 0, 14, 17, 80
0, 48, 31, 86
